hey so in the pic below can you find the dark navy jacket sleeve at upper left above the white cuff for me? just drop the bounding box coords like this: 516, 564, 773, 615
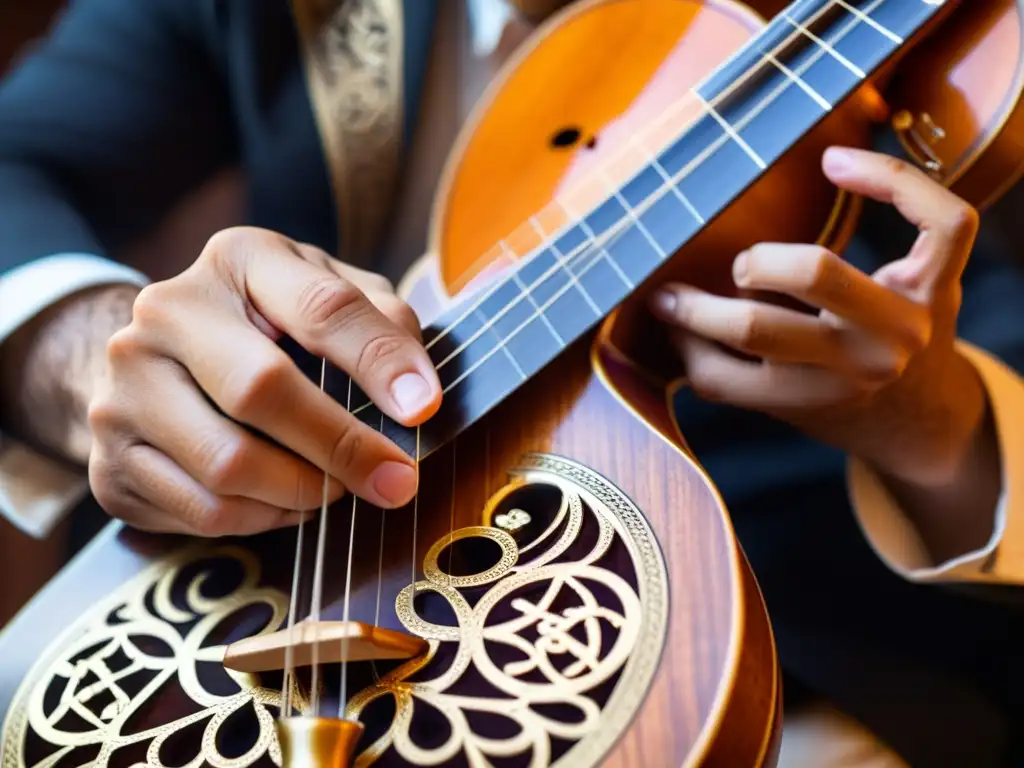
0, 0, 234, 275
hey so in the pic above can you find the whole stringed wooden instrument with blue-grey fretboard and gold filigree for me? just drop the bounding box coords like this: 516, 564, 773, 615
0, 0, 1024, 767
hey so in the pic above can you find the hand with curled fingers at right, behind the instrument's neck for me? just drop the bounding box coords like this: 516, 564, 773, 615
654, 148, 997, 501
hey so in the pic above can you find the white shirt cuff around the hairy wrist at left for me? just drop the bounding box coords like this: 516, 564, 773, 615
0, 254, 148, 538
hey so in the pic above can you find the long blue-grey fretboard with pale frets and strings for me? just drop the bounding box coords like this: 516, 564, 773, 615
352, 0, 945, 458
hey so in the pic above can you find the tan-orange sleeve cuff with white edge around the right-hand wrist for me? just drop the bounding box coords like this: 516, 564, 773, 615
848, 342, 1024, 584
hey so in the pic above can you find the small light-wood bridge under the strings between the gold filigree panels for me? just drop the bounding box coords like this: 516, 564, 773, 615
223, 621, 427, 673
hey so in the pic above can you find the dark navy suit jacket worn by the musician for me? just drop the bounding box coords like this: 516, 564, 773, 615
6, 0, 1024, 768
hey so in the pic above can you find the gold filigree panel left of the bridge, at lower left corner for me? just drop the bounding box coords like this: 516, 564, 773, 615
3, 547, 296, 768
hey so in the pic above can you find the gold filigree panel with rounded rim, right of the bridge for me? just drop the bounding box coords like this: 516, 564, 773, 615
347, 455, 668, 766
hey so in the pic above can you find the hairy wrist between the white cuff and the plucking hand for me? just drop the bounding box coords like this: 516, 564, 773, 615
0, 286, 139, 465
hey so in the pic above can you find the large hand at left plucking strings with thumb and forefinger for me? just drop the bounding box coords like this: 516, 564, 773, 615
89, 228, 441, 536
